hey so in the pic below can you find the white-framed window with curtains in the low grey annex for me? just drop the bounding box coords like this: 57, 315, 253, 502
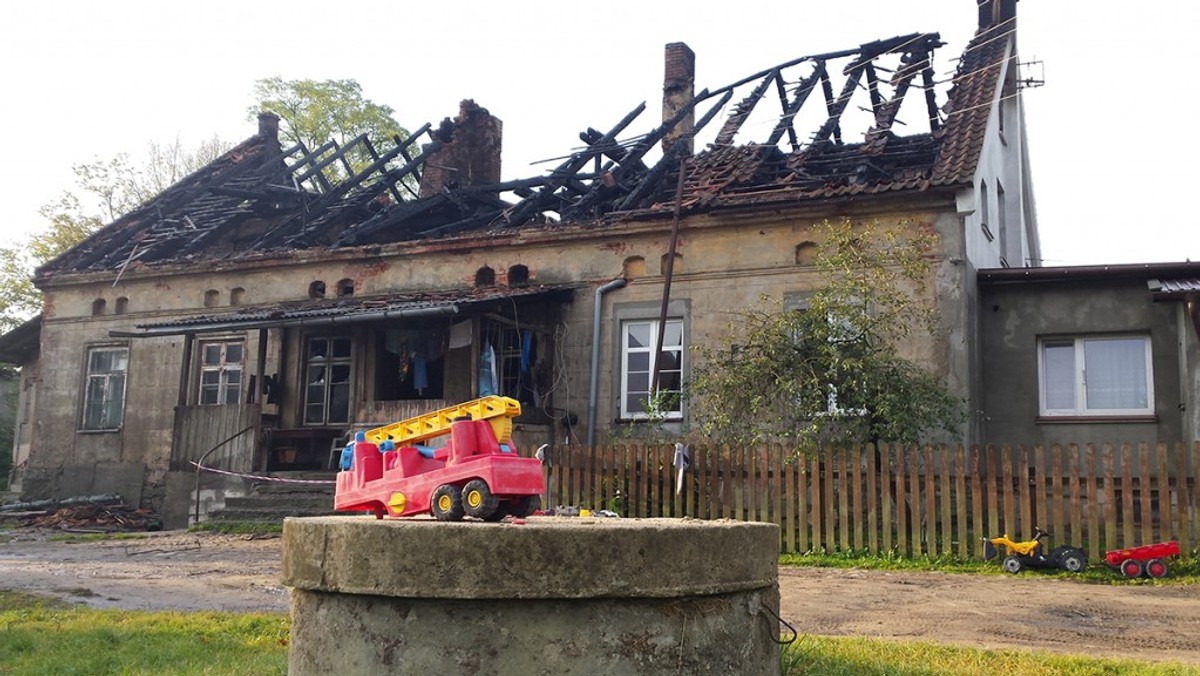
1038, 336, 1154, 415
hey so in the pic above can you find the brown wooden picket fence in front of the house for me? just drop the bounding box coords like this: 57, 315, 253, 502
542, 441, 1200, 561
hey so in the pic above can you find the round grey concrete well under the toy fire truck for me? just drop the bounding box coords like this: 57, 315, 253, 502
283, 516, 780, 676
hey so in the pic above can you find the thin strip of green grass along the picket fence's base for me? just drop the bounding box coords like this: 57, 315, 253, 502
779, 551, 1200, 585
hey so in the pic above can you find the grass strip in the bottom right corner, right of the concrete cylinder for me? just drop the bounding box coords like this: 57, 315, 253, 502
780, 636, 1200, 676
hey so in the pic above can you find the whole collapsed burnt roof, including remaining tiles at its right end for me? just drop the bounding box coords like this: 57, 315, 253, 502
38, 9, 1015, 280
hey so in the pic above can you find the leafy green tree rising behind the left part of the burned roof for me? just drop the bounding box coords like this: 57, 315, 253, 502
250, 77, 408, 180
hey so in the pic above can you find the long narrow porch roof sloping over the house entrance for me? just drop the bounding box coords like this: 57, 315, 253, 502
112, 285, 580, 337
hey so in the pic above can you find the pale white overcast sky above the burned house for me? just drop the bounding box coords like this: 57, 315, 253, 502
0, 0, 1200, 265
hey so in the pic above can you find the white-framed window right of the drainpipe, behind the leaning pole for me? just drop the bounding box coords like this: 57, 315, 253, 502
620, 319, 683, 419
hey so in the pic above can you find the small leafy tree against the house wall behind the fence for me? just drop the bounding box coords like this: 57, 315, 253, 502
689, 221, 961, 445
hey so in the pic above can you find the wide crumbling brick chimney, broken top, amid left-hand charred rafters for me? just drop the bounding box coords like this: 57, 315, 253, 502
419, 98, 503, 197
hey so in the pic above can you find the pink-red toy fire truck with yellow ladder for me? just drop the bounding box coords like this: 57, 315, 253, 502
334, 396, 545, 521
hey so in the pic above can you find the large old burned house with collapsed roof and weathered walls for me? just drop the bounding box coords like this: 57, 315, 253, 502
0, 0, 1039, 521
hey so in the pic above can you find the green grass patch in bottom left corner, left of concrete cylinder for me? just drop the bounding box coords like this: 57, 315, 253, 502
0, 591, 288, 676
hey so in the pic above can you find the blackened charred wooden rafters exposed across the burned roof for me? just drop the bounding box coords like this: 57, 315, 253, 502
42, 32, 960, 270
